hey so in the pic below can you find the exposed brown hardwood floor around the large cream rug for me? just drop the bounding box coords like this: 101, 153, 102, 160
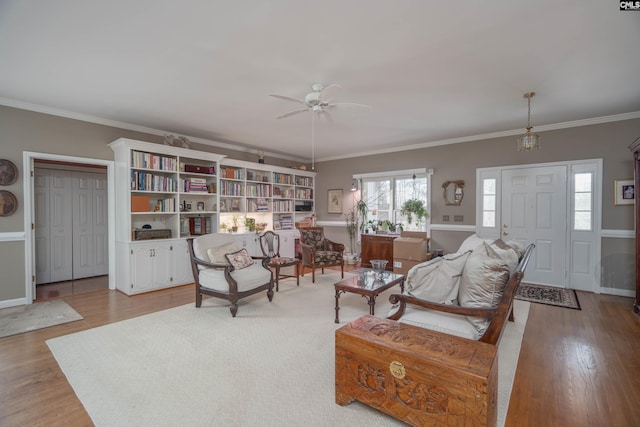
0, 269, 640, 427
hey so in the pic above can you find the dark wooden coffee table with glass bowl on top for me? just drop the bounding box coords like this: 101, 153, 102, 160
333, 270, 405, 323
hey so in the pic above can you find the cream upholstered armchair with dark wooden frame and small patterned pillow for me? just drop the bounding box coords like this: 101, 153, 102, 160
187, 233, 273, 317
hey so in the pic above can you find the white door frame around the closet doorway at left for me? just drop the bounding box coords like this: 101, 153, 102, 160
22, 151, 116, 304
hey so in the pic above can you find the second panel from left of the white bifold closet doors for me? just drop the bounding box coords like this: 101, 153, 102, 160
49, 170, 73, 282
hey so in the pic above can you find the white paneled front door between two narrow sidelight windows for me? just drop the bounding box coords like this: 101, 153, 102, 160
501, 166, 567, 288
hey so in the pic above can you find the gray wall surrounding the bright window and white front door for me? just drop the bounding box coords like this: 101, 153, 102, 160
316, 119, 640, 290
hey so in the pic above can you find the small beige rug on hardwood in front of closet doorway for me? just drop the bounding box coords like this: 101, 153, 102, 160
0, 300, 83, 338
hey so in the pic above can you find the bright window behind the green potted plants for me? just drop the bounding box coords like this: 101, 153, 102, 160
360, 173, 431, 231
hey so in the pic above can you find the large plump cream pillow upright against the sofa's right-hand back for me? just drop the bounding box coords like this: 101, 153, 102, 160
458, 243, 509, 333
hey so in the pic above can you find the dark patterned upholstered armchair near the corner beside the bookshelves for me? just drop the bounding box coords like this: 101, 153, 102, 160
300, 227, 344, 283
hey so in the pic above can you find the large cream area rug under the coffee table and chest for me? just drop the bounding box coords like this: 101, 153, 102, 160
47, 272, 529, 427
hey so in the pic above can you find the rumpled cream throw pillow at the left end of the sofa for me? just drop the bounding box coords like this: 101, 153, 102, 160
407, 252, 471, 304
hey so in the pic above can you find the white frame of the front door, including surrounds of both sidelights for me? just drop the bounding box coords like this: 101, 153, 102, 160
476, 159, 602, 293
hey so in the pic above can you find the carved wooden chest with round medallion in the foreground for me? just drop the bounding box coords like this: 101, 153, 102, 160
335, 316, 498, 427
